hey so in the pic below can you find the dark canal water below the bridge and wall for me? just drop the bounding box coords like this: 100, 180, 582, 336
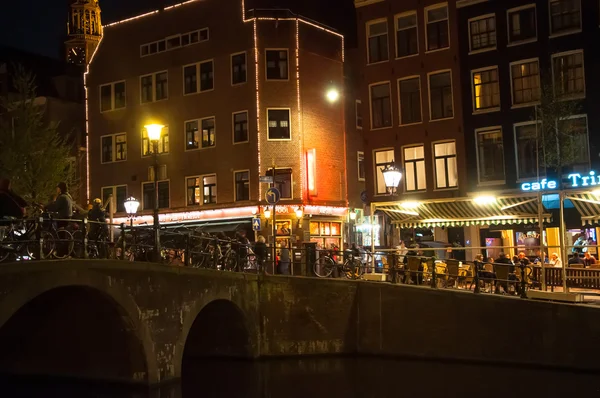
0, 358, 600, 398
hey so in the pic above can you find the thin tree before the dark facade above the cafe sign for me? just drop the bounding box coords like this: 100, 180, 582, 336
534, 76, 588, 178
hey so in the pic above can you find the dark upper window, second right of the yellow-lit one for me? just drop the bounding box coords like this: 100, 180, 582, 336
552, 50, 585, 97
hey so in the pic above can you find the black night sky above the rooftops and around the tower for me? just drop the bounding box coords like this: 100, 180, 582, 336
0, 0, 356, 57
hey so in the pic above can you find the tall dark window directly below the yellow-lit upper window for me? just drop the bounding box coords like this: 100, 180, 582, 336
475, 128, 505, 182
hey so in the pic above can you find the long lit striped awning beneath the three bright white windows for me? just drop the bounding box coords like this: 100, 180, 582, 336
376, 197, 552, 228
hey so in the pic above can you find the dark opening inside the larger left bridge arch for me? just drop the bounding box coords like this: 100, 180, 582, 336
0, 286, 148, 382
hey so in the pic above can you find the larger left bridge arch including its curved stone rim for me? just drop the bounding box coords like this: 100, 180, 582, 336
0, 270, 160, 383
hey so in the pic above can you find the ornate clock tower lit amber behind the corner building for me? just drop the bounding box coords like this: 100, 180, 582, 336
65, 0, 102, 66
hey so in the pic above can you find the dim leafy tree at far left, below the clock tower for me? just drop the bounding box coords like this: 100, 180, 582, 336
0, 65, 75, 203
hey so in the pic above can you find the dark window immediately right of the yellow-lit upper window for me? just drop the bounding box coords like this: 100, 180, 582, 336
510, 59, 541, 105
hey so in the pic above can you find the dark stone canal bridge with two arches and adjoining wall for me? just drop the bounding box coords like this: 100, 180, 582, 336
0, 260, 600, 384
